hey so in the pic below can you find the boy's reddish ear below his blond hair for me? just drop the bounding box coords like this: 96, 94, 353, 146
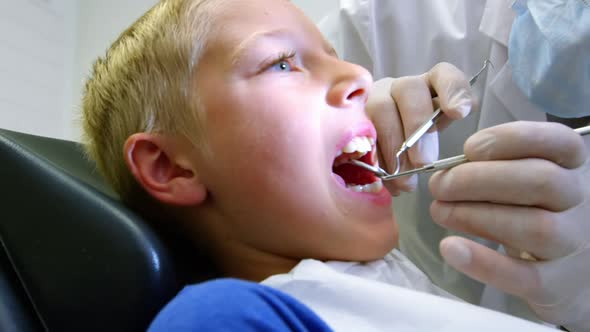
124, 133, 207, 206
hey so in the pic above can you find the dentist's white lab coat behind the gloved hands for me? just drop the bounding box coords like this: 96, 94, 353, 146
318, 0, 590, 319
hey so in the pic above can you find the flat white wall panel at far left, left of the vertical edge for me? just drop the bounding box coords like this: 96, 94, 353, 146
0, 0, 77, 138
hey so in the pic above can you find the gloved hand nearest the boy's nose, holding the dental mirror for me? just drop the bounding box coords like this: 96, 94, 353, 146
366, 63, 476, 195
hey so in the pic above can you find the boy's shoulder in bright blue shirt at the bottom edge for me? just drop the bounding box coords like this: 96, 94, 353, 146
149, 279, 331, 331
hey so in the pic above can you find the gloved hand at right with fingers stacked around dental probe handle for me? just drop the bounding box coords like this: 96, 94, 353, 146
429, 122, 590, 331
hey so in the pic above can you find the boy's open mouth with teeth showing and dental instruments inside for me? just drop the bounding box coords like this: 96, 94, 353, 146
332, 136, 383, 193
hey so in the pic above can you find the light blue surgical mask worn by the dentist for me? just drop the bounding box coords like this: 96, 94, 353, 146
508, 0, 590, 118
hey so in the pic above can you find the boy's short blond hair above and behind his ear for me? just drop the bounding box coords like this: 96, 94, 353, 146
82, 0, 217, 200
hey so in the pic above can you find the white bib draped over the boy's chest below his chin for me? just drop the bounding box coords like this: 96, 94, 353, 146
262, 250, 550, 332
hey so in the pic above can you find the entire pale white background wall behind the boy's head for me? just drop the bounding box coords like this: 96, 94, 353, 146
0, 0, 338, 140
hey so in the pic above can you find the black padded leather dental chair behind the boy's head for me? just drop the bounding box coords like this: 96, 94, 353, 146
0, 129, 211, 331
